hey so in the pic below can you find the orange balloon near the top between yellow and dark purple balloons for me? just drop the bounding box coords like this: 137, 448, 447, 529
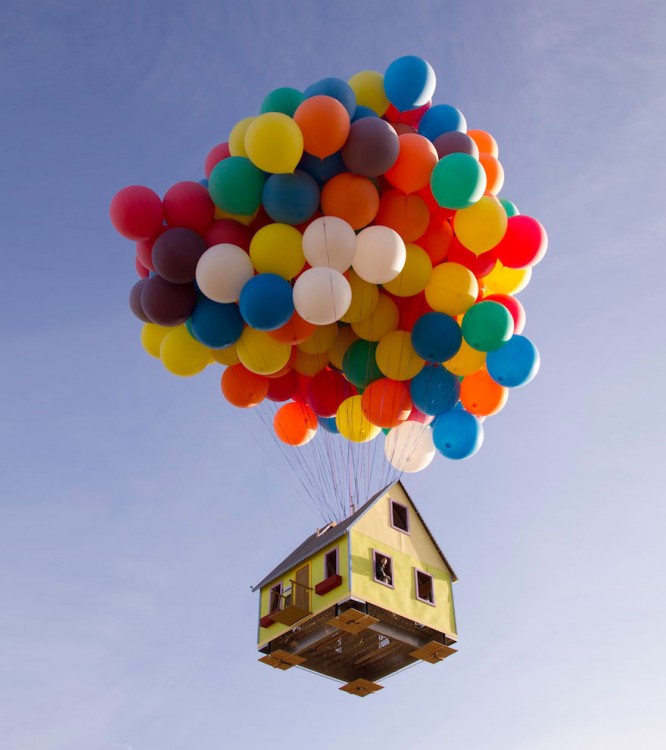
294, 96, 350, 159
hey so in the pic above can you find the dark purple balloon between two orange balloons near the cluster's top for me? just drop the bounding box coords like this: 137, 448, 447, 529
340, 117, 400, 177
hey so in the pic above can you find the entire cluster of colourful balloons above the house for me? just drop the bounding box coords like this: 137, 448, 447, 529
111, 56, 547, 471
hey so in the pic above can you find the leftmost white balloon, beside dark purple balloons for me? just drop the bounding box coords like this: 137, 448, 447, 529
196, 243, 254, 302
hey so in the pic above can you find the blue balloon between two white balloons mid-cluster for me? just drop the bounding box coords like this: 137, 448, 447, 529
238, 273, 294, 331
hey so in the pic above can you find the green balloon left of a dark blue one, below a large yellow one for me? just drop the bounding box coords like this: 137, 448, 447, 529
208, 156, 266, 216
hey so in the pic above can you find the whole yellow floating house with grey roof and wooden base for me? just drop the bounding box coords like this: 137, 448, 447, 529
253, 482, 458, 696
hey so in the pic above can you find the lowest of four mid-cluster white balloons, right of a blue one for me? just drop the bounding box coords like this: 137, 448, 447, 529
294, 267, 351, 326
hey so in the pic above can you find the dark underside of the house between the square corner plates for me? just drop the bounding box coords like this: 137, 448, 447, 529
262, 604, 446, 682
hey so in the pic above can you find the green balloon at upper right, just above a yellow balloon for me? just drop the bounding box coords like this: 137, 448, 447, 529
430, 152, 486, 209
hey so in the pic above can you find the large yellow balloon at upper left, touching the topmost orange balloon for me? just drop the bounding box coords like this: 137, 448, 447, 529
245, 112, 303, 174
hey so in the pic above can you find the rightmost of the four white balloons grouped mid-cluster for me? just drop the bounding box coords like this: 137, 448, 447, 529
352, 224, 407, 284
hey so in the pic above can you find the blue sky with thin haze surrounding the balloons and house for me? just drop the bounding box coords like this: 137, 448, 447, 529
0, 0, 666, 750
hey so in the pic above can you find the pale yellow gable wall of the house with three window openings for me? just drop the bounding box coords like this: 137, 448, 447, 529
350, 485, 456, 635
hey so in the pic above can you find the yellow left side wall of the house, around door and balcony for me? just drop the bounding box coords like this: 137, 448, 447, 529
258, 534, 349, 647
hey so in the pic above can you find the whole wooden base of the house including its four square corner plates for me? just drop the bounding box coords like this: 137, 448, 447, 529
255, 600, 455, 696
